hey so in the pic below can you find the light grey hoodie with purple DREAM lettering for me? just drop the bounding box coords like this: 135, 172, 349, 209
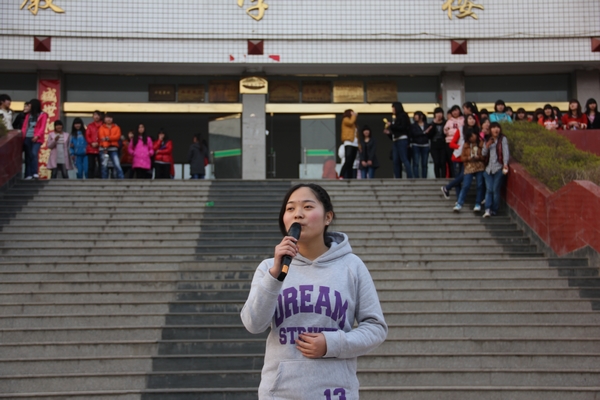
241, 232, 387, 400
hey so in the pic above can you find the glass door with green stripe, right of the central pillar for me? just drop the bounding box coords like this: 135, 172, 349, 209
299, 114, 336, 179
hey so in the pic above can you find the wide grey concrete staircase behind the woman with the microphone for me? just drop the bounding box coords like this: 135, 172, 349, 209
0, 180, 600, 400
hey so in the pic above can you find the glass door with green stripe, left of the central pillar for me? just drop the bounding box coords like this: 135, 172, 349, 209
208, 114, 242, 179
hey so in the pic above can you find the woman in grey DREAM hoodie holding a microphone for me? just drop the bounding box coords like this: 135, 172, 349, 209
241, 184, 388, 400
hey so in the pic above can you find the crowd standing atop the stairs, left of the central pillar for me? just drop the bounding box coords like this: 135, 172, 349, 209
0, 94, 209, 180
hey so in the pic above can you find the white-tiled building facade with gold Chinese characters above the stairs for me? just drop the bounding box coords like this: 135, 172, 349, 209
0, 0, 600, 179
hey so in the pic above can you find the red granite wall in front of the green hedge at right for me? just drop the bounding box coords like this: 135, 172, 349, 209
506, 162, 600, 256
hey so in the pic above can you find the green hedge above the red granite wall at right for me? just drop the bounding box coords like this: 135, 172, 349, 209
502, 122, 600, 191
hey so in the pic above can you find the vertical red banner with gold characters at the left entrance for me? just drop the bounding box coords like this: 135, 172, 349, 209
38, 79, 60, 179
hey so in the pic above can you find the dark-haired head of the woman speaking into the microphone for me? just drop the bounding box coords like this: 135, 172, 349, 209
283, 187, 333, 247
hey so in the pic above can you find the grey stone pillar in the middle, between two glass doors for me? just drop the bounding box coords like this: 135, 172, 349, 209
242, 94, 267, 179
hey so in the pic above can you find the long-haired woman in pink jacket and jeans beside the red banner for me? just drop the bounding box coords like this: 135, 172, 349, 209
21, 99, 48, 179
